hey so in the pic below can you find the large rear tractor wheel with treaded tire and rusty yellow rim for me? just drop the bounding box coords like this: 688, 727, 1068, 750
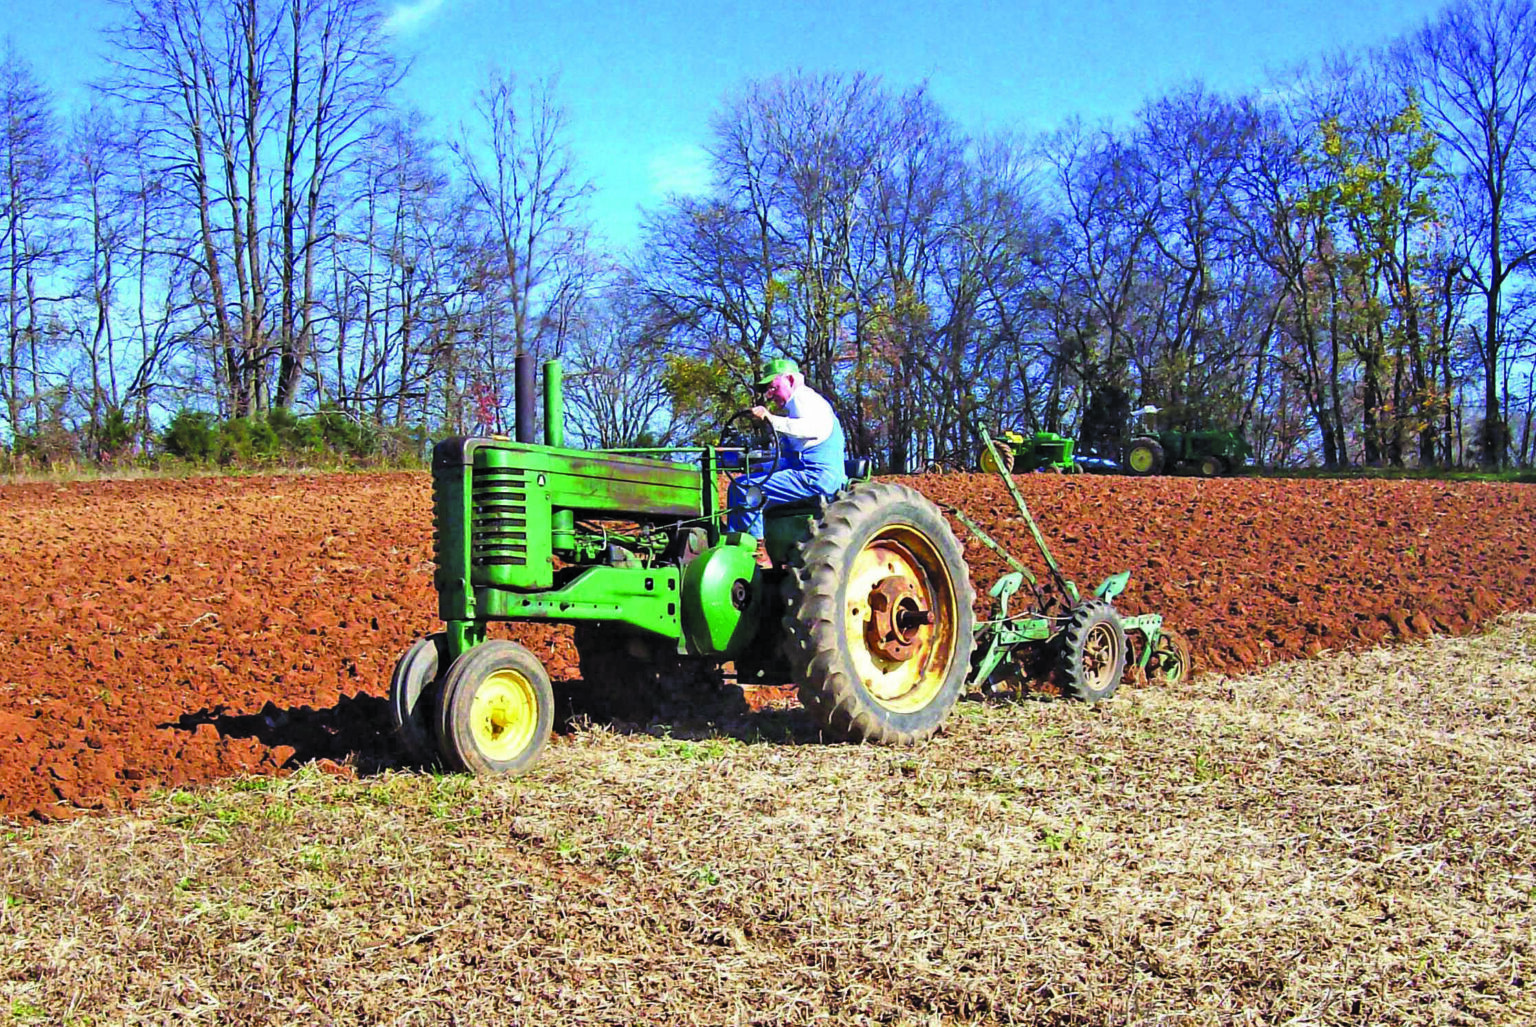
783, 482, 975, 745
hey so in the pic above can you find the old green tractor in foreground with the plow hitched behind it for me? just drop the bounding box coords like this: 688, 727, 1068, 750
390, 356, 1189, 774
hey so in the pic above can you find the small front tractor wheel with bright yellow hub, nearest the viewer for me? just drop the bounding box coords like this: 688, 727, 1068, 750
438, 640, 554, 774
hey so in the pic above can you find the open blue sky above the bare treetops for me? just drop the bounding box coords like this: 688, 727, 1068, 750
0, 0, 1444, 246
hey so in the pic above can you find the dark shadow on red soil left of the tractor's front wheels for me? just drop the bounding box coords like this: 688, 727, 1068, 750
157, 692, 410, 774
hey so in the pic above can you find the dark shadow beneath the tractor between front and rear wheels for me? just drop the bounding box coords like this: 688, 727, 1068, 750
554, 680, 828, 745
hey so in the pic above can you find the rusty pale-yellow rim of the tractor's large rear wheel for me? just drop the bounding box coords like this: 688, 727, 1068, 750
843, 525, 958, 714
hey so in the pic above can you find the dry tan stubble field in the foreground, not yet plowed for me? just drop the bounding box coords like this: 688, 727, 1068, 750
0, 616, 1536, 1025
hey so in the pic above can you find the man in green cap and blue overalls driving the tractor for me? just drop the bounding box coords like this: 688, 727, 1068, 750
725, 358, 848, 539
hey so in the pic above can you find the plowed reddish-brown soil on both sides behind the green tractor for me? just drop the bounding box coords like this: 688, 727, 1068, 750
0, 473, 1536, 820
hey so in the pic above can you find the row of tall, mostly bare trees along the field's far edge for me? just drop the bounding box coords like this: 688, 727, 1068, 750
0, 0, 1536, 470
